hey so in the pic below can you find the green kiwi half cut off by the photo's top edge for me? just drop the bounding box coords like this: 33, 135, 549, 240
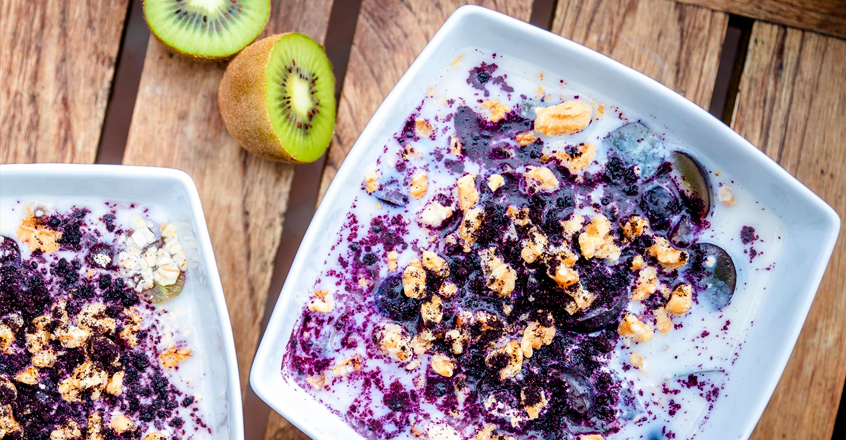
144, 0, 270, 60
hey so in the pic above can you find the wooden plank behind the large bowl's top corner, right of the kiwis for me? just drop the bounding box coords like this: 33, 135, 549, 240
319, 0, 532, 203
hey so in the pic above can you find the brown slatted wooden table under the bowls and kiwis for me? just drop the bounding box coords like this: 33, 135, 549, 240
0, 0, 846, 440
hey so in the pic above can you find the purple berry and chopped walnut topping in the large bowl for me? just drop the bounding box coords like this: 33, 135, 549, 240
282, 52, 748, 440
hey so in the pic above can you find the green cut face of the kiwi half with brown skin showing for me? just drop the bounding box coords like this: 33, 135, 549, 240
265, 33, 335, 162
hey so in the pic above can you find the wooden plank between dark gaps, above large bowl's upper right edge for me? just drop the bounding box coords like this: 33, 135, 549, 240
552, 0, 728, 109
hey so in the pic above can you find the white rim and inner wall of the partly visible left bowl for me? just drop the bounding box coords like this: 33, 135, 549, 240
0, 164, 244, 440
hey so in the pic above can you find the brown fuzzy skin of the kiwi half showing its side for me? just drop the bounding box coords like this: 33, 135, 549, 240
217, 33, 332, 163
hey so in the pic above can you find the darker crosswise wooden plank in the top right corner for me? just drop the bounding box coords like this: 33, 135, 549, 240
676, 0, 846, 37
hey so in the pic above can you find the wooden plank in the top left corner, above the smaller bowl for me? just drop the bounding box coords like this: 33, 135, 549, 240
0, 0, 128, 163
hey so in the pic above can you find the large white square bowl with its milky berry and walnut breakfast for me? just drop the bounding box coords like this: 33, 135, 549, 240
251, 6, 839, 440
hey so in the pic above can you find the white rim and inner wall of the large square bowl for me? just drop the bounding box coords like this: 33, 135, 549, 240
250, 6, 840, 440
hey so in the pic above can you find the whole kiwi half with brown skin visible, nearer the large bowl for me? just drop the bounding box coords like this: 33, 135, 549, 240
218, 33, 335, 162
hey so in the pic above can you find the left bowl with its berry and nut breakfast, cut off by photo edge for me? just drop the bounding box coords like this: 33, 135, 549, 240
0, 164, 243, 439
